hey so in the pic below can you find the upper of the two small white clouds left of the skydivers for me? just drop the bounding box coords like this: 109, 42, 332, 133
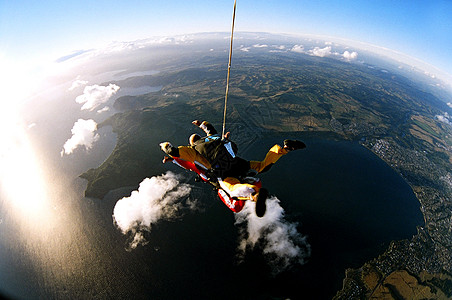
75, 83, 119, 111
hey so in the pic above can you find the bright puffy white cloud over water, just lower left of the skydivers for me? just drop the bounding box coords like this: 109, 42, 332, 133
113, 172, 197, 250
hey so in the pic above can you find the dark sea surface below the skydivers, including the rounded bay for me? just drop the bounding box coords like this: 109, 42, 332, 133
0, 135, 423, 299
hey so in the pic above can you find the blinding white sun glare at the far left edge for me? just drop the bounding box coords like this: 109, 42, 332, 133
0, 55, 52, 217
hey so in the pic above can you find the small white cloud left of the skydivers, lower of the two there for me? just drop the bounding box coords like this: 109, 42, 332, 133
61, 119, 99, 156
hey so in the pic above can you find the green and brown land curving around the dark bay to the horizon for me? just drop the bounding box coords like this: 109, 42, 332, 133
81, 54, 452, 299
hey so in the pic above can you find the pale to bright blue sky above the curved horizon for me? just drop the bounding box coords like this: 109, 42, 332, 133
0, 0, 452, 81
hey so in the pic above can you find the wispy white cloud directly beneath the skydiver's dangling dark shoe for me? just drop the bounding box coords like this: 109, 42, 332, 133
235, 197, 311, 273
